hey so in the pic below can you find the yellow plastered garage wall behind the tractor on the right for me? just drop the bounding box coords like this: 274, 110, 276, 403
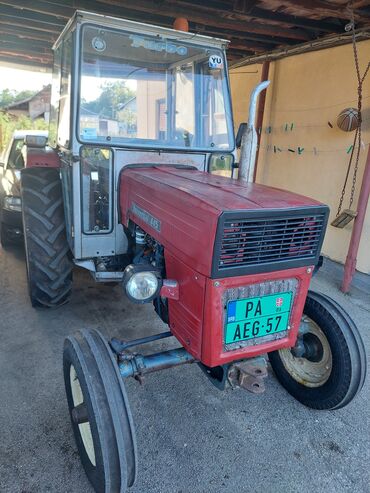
230, 41, 370, 273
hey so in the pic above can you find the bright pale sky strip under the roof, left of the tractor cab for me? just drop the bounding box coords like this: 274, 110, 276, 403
0, 66, 51, 91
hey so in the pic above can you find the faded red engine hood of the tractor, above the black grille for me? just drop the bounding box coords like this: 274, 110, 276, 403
119, 165, 326, 275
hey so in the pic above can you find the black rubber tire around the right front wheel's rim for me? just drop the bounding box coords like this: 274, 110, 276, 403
269, 291, 366, 410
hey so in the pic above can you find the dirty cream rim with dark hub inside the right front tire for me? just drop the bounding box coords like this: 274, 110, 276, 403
279, 315, 333, 388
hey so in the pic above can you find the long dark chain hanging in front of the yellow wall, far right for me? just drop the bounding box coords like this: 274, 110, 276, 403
337, 10, 370, 216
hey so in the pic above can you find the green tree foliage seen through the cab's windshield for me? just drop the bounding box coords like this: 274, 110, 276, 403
82, 81, 135, 119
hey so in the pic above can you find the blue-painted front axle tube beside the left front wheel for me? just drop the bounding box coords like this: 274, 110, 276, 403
118, 348, 195, 378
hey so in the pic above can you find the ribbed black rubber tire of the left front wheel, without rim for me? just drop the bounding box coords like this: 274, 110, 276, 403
63, 330, 137, 493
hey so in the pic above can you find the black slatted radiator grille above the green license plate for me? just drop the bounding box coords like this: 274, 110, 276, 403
214, 211, 327, 272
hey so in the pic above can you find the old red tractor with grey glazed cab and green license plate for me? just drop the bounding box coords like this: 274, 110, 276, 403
21, 8, 366, 492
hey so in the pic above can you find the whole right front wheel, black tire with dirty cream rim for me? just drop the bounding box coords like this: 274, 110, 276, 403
269, 291, 366, 409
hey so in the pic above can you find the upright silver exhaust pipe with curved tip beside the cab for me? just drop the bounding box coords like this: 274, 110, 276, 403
238, 80, 270, 182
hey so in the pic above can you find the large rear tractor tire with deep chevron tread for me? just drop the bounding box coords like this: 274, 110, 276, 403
21, 168, 73, 308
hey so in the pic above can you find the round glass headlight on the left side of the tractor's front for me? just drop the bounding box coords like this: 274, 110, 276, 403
123, 265, 161, 303
